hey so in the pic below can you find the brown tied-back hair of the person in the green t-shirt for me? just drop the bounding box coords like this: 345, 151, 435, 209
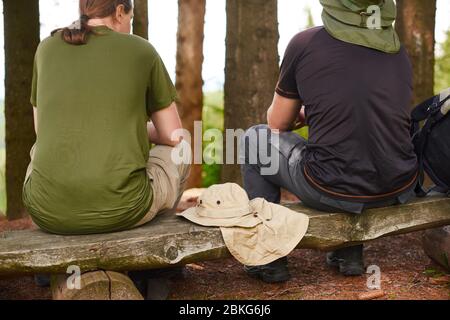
52, 0, 133, 45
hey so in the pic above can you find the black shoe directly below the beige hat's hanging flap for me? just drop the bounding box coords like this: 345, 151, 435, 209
244, 257, 291, 283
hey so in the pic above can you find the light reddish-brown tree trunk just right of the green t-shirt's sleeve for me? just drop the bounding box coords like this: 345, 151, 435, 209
176, 0, 206, 188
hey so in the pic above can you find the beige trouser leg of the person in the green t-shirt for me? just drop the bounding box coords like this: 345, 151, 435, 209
134, 142, 191, 227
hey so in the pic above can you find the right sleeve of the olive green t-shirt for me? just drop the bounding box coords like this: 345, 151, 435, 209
147, 55, 177, 116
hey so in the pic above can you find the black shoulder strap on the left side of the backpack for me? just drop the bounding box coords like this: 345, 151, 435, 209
411, 95, 450, 197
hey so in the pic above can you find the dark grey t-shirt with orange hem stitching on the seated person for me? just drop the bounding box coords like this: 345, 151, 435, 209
277, 27, 417, 197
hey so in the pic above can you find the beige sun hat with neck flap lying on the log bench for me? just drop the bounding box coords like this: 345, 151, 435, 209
178, 183, 309, 266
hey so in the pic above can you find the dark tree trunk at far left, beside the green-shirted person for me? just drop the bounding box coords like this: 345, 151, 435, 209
3, 0, 40, 219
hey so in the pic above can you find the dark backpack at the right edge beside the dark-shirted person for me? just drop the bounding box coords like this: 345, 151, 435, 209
411, 88, 450, 197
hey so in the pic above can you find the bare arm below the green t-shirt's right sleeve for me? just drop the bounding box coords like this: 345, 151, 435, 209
147, 102, 183, 147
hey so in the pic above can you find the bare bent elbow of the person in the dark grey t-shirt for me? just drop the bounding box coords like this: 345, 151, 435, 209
267, 93, 306, 132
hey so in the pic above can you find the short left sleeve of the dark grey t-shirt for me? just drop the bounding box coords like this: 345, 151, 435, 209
276, 37, 300, 99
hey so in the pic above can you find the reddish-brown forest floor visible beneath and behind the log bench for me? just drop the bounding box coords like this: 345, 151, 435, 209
0, 190, 450, 300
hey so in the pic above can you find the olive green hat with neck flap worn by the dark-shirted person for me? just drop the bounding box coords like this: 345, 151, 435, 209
320, 0, 400, 53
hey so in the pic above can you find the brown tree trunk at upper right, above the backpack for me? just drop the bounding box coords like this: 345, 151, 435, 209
396, 0, 436, 106
